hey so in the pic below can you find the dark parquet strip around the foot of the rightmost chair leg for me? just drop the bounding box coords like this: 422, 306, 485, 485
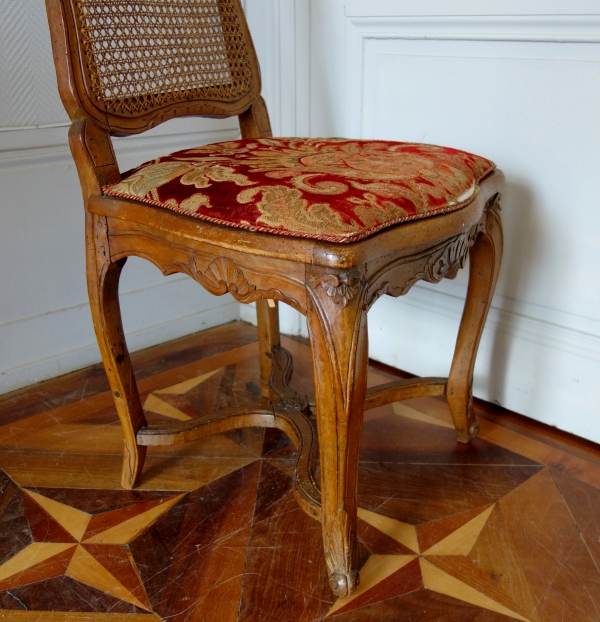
361, 414, 537, 465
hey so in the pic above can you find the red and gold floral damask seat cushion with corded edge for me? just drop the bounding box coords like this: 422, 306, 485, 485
104, 138, 494, 242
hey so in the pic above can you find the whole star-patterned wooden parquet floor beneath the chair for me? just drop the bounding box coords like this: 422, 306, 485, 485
0, 323, 600, 622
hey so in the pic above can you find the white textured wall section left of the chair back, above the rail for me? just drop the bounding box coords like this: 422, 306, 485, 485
0, 0, 68, 128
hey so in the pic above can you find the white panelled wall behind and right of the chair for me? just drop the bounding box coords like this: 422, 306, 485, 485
330, 0, 600, 441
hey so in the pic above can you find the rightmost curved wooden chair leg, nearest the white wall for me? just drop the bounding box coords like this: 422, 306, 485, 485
446, 200, 503, 443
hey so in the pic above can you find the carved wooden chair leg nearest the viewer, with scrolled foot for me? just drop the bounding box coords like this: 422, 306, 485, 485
307, 273, 368, 597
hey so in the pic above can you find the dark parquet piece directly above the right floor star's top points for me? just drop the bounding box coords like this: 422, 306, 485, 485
358, 463, 542, 525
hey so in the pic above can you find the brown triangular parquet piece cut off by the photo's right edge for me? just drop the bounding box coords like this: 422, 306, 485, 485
550, 469, 600, 568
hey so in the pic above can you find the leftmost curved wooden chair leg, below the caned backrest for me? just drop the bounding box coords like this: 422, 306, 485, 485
86, 213, 147, 489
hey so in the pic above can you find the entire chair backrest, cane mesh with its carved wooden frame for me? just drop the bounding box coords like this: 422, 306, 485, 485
46, 0, 261, 134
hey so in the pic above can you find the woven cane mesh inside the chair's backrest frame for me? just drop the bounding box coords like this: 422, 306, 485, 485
77, 0, 253, 113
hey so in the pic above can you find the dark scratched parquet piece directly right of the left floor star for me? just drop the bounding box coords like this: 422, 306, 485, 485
130, 462, 260, 622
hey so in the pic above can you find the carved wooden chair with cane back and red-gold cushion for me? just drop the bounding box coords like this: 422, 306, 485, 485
46, 0, 503, 596
